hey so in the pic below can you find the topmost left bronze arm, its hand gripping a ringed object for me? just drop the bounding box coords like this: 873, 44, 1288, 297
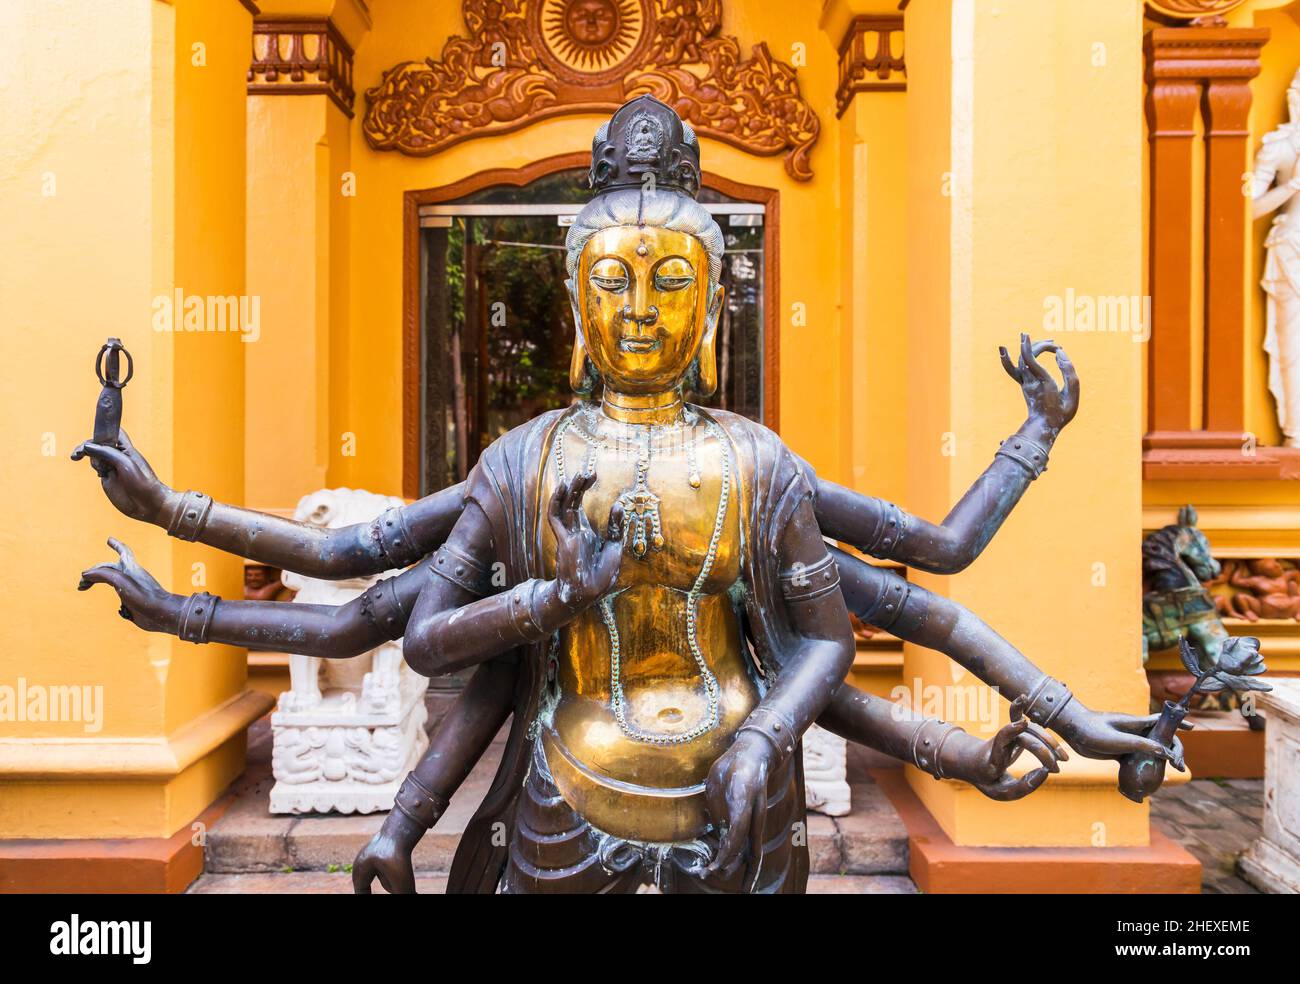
73, 432, 464, 580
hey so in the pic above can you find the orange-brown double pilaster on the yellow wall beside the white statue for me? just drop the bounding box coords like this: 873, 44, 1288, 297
1143, 27, 1263, 457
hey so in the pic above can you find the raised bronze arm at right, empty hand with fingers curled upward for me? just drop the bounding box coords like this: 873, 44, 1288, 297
805, 335, 1079, 575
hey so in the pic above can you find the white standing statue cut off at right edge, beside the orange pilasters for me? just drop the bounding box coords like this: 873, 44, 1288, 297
1251, 71, 1300, 447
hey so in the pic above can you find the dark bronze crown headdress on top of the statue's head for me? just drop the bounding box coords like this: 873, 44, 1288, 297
589, 96, 699, 198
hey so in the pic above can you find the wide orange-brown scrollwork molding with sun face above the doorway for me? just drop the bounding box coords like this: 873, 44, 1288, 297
361, 0, 820, 181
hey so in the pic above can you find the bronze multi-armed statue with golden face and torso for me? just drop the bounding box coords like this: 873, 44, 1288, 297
74, 96, 1182, 893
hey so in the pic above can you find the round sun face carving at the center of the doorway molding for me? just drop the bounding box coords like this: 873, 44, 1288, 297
538, 0, 646, 78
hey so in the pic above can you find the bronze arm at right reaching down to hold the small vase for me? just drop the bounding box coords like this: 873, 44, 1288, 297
832, 547, 1183, 770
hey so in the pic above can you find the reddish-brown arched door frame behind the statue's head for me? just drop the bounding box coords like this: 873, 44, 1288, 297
402, 152, 781, 499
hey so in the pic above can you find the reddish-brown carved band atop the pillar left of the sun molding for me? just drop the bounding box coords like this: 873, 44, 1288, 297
248, 18, 356, 120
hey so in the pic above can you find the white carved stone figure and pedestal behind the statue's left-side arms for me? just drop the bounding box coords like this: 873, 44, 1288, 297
270, 489, 429, 814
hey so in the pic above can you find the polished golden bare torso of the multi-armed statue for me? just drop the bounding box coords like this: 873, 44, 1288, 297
540, 402, 759, 841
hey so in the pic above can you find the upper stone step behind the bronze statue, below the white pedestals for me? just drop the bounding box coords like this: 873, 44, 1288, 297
204, 721, 910, 892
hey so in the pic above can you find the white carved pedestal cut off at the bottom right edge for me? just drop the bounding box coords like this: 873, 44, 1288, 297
1239, 677, 1300, 894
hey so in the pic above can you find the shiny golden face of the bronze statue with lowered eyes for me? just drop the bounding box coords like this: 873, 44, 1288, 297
575, 225, 716, 394
